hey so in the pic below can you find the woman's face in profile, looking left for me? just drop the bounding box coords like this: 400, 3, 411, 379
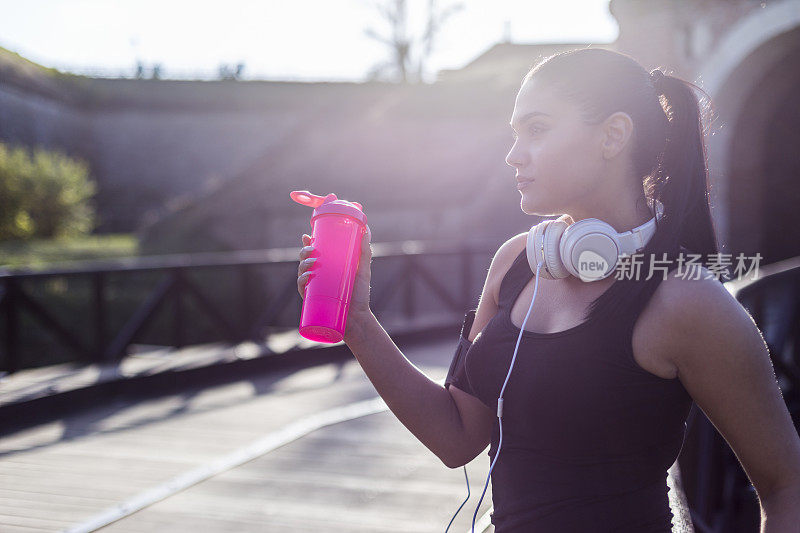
506, 78, 603, 216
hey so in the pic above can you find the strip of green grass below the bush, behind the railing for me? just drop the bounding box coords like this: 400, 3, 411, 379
0, 233, 139, 269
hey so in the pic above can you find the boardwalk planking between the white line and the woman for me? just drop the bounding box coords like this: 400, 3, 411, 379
95, 413, 491, 532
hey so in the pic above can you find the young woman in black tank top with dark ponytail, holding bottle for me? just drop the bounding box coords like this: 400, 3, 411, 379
297, 48, 800, 533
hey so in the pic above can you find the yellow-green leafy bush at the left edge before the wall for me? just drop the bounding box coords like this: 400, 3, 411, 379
0, 143, 96, 240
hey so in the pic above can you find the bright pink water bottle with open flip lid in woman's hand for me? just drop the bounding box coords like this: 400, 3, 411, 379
289, 191, 367, 343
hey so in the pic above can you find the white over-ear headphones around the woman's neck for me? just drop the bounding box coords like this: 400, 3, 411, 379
527, 198, 664, 282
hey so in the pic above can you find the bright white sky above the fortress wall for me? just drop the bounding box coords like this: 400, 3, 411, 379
0, 0, 618, 81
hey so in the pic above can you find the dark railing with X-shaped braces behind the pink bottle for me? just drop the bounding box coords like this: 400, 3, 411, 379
0, 241, 496, 373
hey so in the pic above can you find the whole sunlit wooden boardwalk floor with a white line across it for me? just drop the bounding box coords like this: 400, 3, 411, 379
0, 339, 691, 533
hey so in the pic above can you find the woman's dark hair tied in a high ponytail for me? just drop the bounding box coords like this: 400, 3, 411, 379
523, 48, 719, 318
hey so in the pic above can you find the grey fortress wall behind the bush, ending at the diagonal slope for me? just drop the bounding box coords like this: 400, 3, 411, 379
0, 72, 390, 232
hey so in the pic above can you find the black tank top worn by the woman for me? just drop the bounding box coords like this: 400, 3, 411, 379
445, 249, 692, 533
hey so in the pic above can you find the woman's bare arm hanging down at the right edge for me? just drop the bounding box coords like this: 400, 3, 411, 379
657, 269, 800, 533
